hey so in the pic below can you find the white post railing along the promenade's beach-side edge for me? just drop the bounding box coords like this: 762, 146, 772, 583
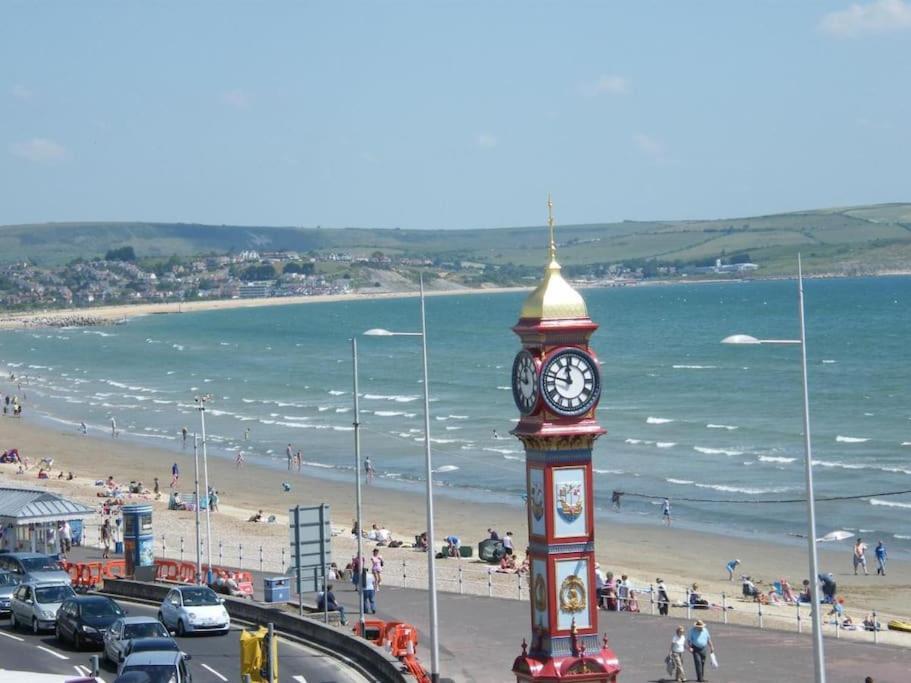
76, 524, 900, 643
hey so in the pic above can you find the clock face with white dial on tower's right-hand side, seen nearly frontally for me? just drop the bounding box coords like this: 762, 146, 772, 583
541, 349, 601, 417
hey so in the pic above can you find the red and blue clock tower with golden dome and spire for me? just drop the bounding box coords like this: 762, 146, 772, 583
512, 196, 620, 683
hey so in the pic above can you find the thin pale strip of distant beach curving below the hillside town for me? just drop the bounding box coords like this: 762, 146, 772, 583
0, 287, 530, 330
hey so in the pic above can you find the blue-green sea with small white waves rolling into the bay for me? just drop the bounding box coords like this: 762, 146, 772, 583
0, 277, 911, 555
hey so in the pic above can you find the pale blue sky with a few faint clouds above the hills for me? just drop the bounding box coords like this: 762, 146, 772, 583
0, 0, 911, 229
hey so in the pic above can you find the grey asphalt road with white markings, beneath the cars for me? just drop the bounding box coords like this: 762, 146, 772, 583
0, 600, 365, 683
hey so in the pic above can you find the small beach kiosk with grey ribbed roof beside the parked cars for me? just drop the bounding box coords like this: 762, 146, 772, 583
0, 486, 94, 555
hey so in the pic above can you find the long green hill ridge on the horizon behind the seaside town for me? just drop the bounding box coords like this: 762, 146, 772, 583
0, 203, 911, 276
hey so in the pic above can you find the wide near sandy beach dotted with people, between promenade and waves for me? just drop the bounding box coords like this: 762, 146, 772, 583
0, 418, 911, 644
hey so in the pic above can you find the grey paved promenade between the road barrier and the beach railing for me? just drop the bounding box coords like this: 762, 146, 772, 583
67, 548, 911, 683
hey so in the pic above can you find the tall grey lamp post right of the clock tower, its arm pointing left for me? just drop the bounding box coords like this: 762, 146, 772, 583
721, 254, 826, 683
